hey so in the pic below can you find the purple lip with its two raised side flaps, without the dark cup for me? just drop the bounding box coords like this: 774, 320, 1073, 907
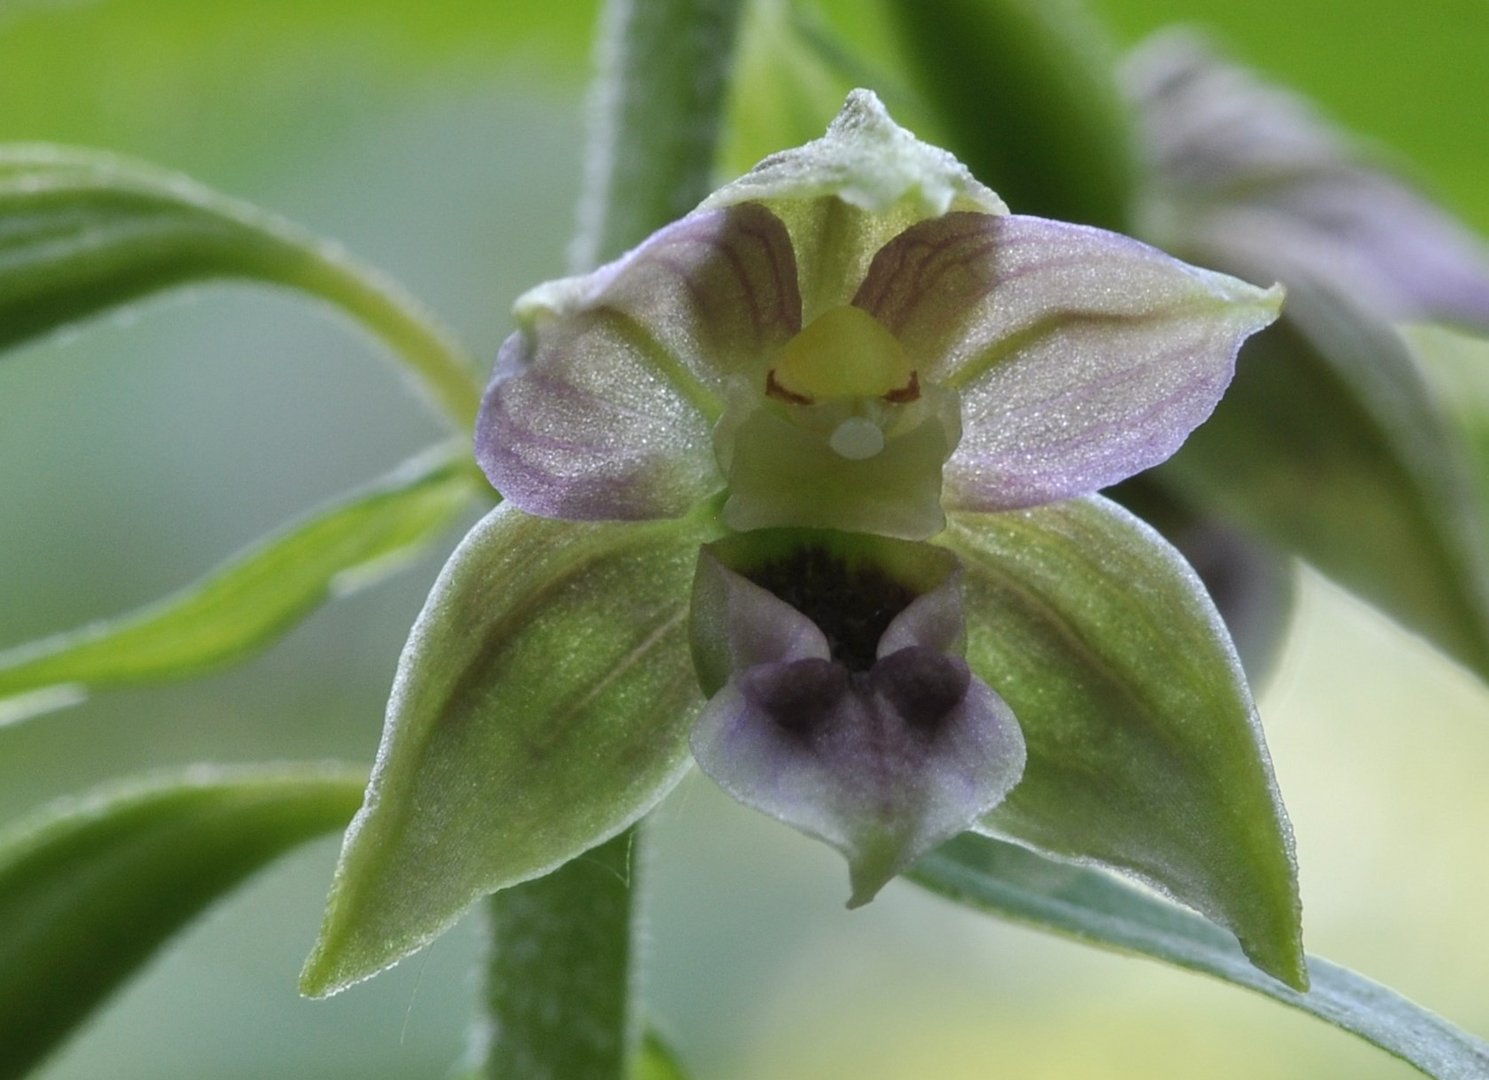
692, 550, 1024, 907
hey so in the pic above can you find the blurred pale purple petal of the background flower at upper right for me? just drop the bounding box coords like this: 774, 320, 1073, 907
1127, 33, 1489, 329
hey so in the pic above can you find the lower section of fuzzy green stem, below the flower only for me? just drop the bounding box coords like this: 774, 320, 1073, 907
481, 830, 645, 1080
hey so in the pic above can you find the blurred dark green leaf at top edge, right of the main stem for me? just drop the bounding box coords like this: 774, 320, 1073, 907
887, 0, 1139, 231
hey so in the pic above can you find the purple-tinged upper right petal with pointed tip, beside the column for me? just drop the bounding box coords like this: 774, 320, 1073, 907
853, 213, 1281, 509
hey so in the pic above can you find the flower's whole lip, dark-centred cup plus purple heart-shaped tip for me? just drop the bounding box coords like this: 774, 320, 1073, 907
691, 529, 1024, 906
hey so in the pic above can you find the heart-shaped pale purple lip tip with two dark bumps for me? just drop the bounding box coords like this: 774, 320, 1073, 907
692, 647, 1024, 907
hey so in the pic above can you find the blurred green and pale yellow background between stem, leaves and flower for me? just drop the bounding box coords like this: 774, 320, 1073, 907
0, 0, 1489, 1080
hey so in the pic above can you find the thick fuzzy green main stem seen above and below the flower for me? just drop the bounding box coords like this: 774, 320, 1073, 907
481, 0, 743, 1080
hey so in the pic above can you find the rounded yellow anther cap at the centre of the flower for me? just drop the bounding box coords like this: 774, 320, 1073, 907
768, 304, 919, 402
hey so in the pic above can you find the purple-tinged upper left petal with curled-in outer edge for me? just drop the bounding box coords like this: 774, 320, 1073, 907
476, 206, 801, 520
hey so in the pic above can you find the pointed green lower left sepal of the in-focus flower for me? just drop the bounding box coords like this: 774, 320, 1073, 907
301, 506, 712, 997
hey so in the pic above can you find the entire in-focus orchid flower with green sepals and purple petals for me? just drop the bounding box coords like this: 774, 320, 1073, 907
307, 91, 1303, 992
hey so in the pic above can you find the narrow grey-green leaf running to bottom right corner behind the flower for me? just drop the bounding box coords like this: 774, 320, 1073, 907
910, 836, 1489, 1080
